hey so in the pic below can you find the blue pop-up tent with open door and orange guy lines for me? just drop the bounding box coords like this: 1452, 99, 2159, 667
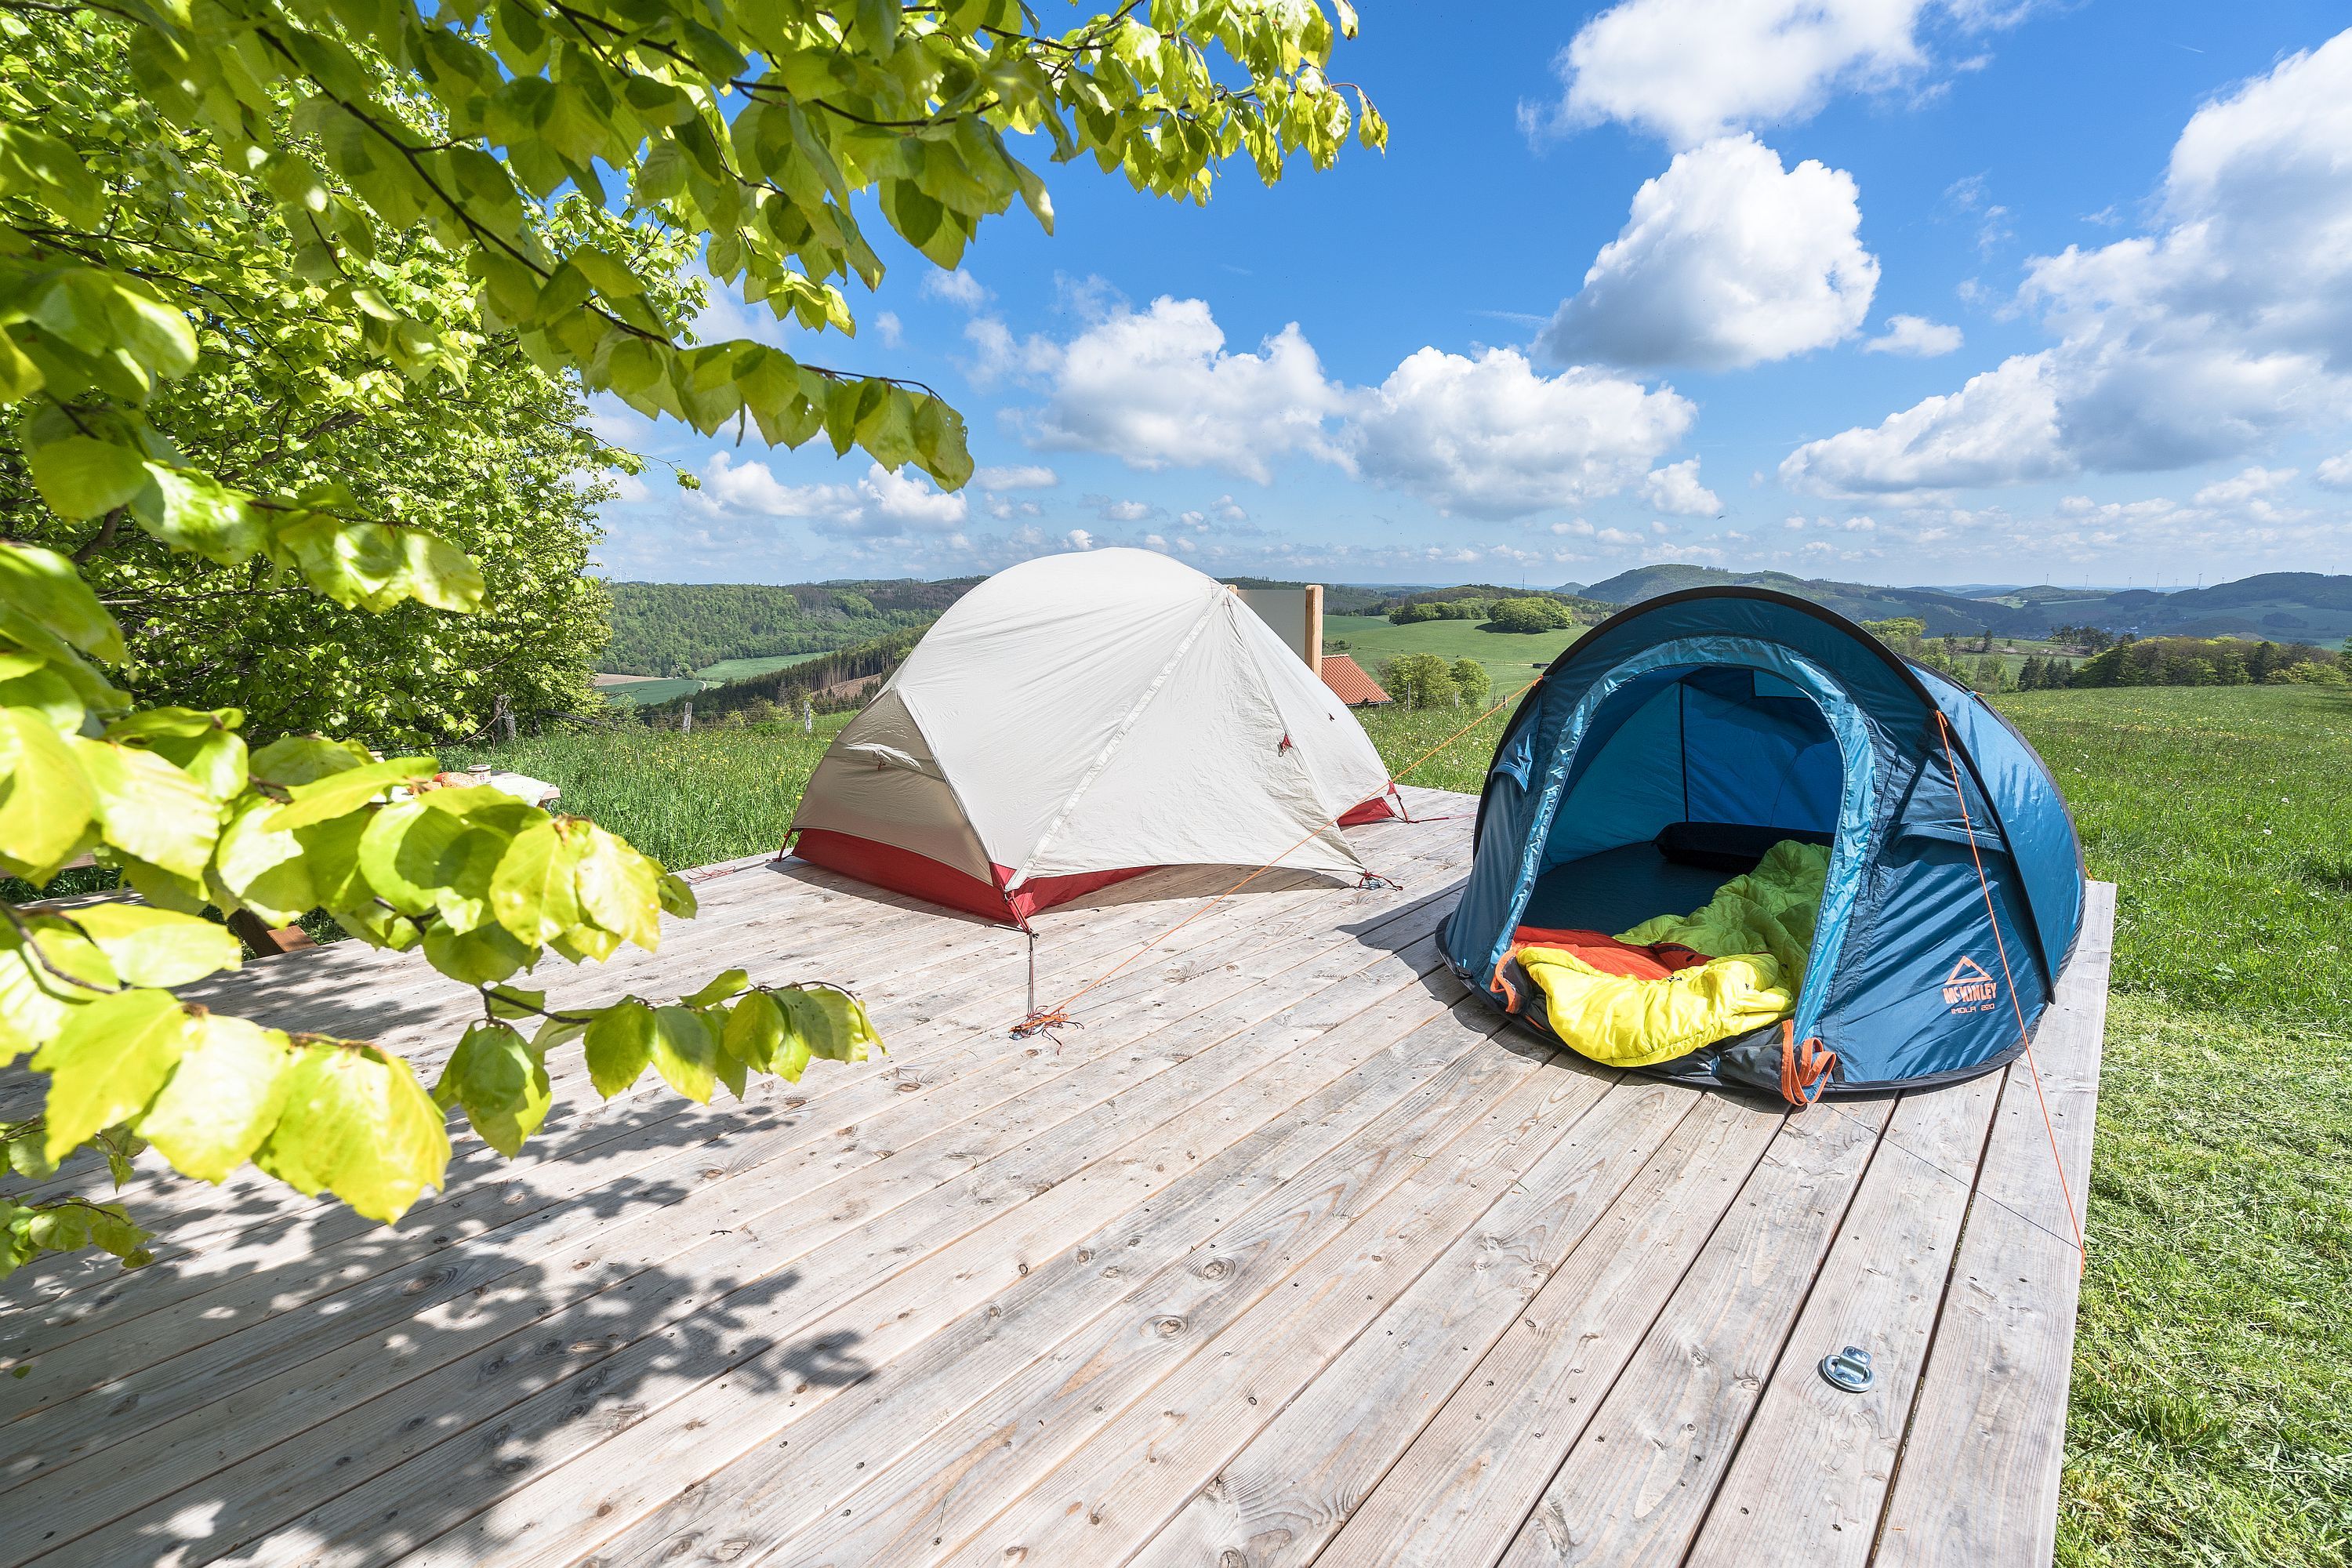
1442, 588, 2084, 1100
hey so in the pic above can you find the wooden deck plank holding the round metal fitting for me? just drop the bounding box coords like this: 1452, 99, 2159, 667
1689, 1072, 2002, 1568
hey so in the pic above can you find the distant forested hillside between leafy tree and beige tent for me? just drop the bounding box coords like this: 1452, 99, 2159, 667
595, 579, 981, 675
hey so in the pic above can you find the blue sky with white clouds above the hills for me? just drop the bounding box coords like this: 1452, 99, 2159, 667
600, 0, 2352, 586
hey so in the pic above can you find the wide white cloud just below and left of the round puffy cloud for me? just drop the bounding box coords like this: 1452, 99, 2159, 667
1345, 348, 1696, 517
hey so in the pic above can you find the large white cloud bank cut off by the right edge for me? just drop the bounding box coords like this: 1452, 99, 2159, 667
1780, 33, 2352, 494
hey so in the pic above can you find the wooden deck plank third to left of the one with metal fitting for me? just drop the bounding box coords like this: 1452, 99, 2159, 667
1131, 1079, 1700, 1568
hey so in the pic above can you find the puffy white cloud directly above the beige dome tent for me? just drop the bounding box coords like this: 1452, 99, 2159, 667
1033, 296, 1343, 485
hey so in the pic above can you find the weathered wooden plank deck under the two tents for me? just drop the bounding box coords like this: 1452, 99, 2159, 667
0, 789, 2112, 1568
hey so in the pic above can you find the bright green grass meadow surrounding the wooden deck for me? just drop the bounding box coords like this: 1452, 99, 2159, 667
428, 681, 2352, 1568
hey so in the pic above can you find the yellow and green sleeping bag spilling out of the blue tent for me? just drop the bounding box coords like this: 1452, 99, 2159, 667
1519, 839, 1830, 1067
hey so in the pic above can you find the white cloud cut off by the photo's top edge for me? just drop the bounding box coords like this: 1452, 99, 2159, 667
1519, 0, 2030, 146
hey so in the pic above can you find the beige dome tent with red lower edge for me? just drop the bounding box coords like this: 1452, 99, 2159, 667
793, 550, 1402, 924
